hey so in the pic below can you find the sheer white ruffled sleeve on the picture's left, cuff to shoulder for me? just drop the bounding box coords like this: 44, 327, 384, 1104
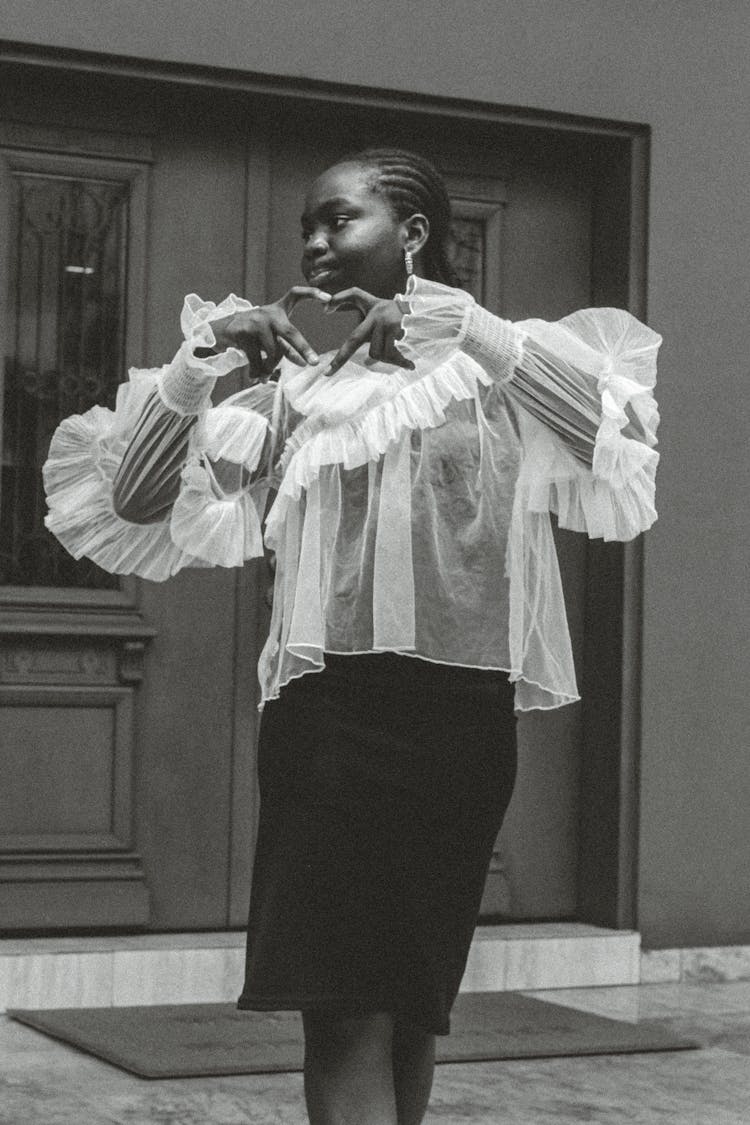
44, 295, 274, 582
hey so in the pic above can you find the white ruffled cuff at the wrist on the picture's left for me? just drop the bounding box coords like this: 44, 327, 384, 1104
159, 293, 253, 414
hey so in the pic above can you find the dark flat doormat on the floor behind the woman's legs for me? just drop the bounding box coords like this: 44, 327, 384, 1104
8, 992, 699, 1078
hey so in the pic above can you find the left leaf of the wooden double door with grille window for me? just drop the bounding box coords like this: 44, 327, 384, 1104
0, 75, 264, 932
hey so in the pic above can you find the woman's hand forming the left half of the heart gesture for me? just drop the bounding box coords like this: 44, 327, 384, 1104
211, 285, 331, 381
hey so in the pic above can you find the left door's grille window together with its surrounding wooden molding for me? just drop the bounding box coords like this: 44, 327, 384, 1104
0, 145, 146, 609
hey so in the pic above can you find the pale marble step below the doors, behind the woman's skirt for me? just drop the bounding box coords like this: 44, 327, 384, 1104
0, 923, 640, 1011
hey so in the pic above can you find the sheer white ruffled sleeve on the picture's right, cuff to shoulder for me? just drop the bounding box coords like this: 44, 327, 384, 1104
398, 278, 661, 541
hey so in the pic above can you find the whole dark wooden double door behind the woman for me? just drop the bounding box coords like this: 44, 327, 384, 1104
0, 69, 624, 932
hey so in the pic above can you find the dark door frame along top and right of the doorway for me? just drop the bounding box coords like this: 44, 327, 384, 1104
0, 44, 650, 929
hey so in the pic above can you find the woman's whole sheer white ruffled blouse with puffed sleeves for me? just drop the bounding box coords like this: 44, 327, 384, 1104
44, 277, 661, 711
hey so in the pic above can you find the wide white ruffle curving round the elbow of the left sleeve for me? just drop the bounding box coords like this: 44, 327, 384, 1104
43, 371, 268, 582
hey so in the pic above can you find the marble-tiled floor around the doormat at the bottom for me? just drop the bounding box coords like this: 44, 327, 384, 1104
0, 981, 750, 1125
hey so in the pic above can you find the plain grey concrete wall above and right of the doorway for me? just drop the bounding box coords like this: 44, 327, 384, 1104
0, 0, 750, 946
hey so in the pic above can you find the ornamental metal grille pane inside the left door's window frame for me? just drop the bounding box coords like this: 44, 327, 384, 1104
0, 171, 129, 590
